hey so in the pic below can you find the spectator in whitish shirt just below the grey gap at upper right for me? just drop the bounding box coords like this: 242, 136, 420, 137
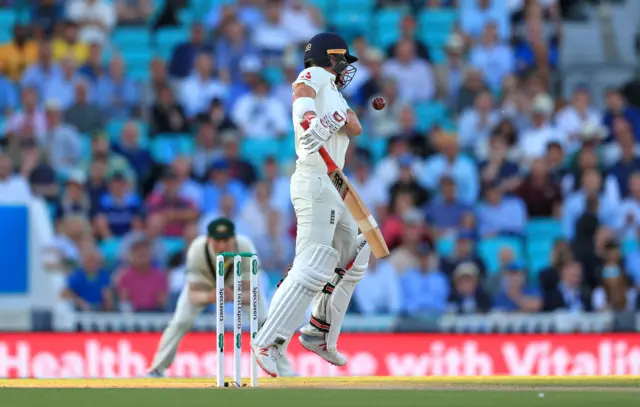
555, 86, 602, 153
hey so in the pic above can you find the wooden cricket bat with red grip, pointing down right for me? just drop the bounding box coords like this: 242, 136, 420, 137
301, 120, 389, 259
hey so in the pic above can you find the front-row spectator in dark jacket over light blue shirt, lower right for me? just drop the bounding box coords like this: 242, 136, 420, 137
543, 261, 591, 312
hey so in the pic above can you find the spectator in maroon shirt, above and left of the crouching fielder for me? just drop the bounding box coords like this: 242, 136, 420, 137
147, 168, 198, 237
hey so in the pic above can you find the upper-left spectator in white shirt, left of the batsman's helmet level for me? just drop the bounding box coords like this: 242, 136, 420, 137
180, 53, 227, 118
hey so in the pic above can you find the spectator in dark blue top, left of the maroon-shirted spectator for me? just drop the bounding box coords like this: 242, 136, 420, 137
93, 171, 144, 239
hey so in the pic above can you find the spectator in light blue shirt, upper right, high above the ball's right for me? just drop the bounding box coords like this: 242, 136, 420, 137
469, 23, 515, 91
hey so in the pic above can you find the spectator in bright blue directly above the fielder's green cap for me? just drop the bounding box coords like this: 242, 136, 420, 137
201, 159, 248, 213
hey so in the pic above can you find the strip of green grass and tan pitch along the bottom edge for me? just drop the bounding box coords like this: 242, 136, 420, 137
0, 376, 640, 407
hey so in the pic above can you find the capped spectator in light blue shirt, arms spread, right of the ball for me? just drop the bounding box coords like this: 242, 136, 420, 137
418, 134, 480, 204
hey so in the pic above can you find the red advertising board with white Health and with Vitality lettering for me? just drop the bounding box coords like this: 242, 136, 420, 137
0, 333, 640, 383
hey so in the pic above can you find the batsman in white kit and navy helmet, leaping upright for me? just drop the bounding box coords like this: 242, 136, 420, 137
252, 32, 362, 377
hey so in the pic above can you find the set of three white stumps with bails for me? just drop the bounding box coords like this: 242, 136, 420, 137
216, 252, 258, 387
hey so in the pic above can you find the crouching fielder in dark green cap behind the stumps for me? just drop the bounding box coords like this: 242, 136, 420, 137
148, 218, 295, 377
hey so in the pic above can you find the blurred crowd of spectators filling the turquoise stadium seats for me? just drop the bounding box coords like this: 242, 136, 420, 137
0, 0, 640, 316
